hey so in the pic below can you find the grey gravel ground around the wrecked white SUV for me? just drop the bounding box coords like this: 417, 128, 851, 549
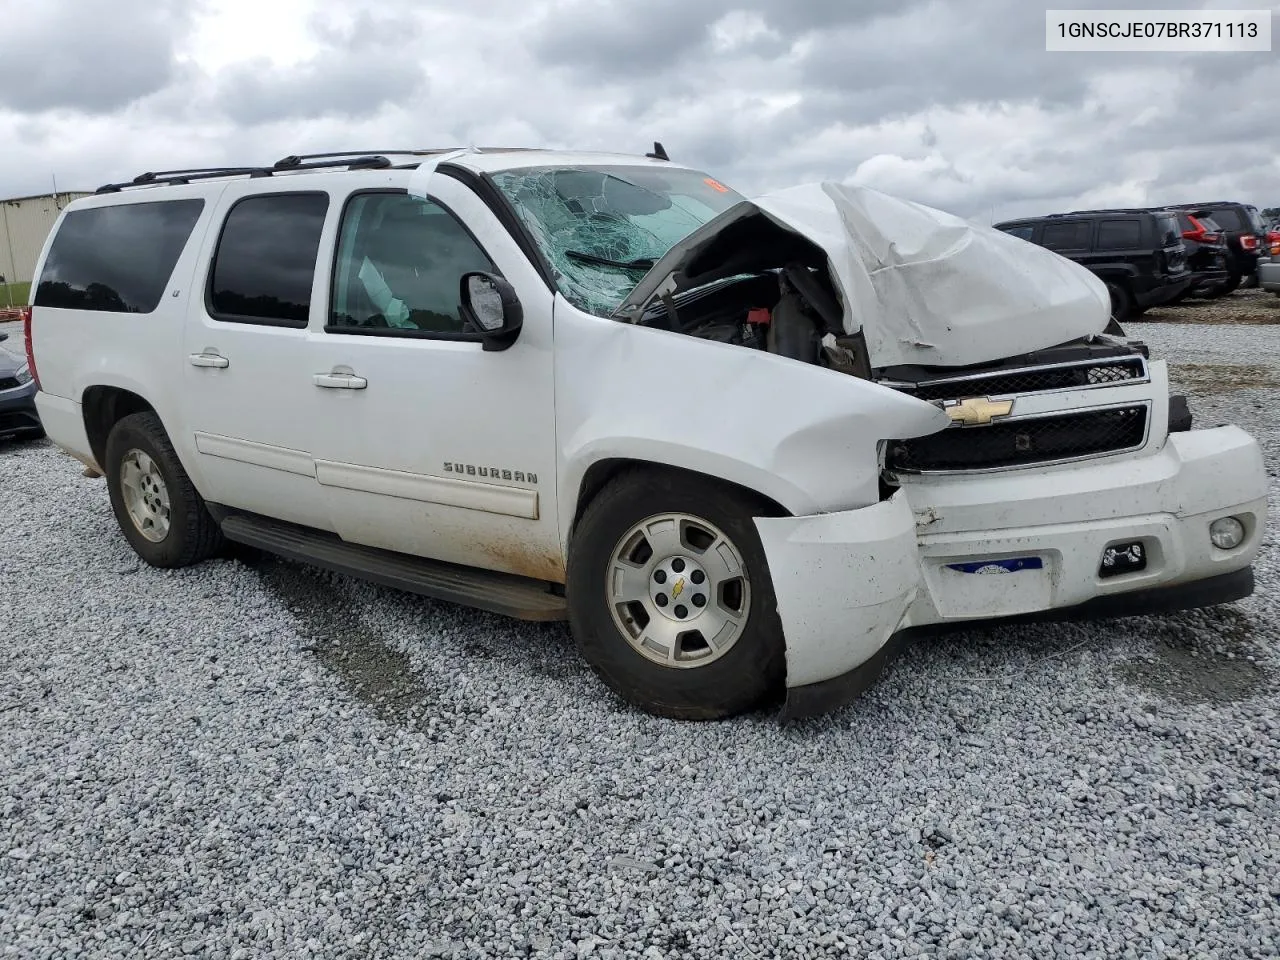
0, 323, 1280, 960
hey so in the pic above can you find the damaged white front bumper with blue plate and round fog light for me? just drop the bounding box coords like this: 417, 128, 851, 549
756, 426, 1267, 718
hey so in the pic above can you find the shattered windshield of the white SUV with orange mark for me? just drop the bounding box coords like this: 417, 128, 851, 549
493, 165, 744, 316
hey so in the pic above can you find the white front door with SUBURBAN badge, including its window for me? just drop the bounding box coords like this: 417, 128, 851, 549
311, 175, 564, 580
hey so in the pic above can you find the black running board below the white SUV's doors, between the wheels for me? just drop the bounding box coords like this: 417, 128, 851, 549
221, 513, 568, 621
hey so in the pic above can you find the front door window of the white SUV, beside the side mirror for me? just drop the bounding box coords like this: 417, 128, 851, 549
325, 193, 494, 337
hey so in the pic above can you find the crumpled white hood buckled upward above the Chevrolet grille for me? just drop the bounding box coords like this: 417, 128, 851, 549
614, 182, 1111, 367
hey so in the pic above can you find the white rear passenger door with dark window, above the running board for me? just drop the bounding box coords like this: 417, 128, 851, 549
182, 188, 340, 529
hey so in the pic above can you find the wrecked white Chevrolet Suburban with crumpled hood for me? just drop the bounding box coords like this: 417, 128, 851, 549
28, 150, 1267, 718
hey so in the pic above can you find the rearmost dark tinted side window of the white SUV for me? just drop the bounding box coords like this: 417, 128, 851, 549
35, 200, 205, 314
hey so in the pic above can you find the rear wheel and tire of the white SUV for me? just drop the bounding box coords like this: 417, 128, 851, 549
102, 412, 223, 567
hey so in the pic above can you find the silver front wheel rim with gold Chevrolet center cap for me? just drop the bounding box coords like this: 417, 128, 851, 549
605, 513, 751, 668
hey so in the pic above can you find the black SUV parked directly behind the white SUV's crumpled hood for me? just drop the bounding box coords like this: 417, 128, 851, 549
995, 209, 1193, 321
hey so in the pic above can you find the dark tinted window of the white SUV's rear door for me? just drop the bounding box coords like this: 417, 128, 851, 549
209, 193, 329, 326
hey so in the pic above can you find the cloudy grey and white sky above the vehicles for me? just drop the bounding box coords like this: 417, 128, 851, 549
0, 0, 1280, 221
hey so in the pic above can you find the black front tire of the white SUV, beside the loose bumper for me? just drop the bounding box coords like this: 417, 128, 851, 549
566, 470, 786, 719
